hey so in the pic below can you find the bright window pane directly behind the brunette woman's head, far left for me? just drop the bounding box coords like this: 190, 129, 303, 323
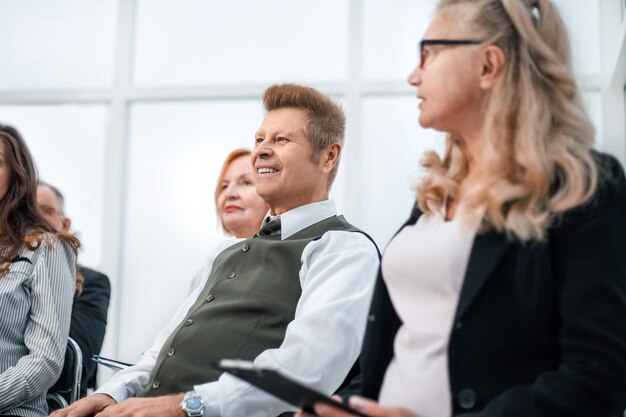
0, 105, 108, 268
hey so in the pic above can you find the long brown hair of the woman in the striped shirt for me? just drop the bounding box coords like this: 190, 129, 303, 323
0, 124, 82, 292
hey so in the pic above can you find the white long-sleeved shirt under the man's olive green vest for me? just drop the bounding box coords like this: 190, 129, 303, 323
97, 200, 378, 417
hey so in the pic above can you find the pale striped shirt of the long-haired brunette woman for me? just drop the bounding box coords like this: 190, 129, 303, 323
0, 234, 76, 417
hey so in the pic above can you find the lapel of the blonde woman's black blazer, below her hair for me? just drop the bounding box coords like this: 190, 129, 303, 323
456, 232, 510, 319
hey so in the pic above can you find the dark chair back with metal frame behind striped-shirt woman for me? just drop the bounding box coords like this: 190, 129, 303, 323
46, 337, 83, 412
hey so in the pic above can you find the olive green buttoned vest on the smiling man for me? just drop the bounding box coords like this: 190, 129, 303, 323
140, 216, 360, 397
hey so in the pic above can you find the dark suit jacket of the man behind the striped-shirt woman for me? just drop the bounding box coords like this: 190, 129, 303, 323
70, 266, 111, 395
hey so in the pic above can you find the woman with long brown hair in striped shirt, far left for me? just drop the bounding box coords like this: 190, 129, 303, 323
0, 124, 79, 417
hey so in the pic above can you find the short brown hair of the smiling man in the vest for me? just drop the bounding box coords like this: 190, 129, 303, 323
263, 84, 346, 187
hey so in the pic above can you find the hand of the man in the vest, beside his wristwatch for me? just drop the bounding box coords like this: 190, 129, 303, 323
92, 394, 187, 417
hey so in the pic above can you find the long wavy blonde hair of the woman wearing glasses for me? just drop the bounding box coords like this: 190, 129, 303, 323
417, 0, 598, 242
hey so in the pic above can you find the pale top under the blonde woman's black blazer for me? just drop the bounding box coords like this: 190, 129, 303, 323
379, 204, 476, 417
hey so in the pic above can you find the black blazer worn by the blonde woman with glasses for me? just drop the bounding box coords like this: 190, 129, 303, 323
361, 155, 626, 417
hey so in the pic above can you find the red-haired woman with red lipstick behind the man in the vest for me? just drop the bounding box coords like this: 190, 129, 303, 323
190, 148, 268, 291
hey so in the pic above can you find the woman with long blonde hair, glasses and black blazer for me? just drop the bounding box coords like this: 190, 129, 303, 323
300, 0, 626, 417
